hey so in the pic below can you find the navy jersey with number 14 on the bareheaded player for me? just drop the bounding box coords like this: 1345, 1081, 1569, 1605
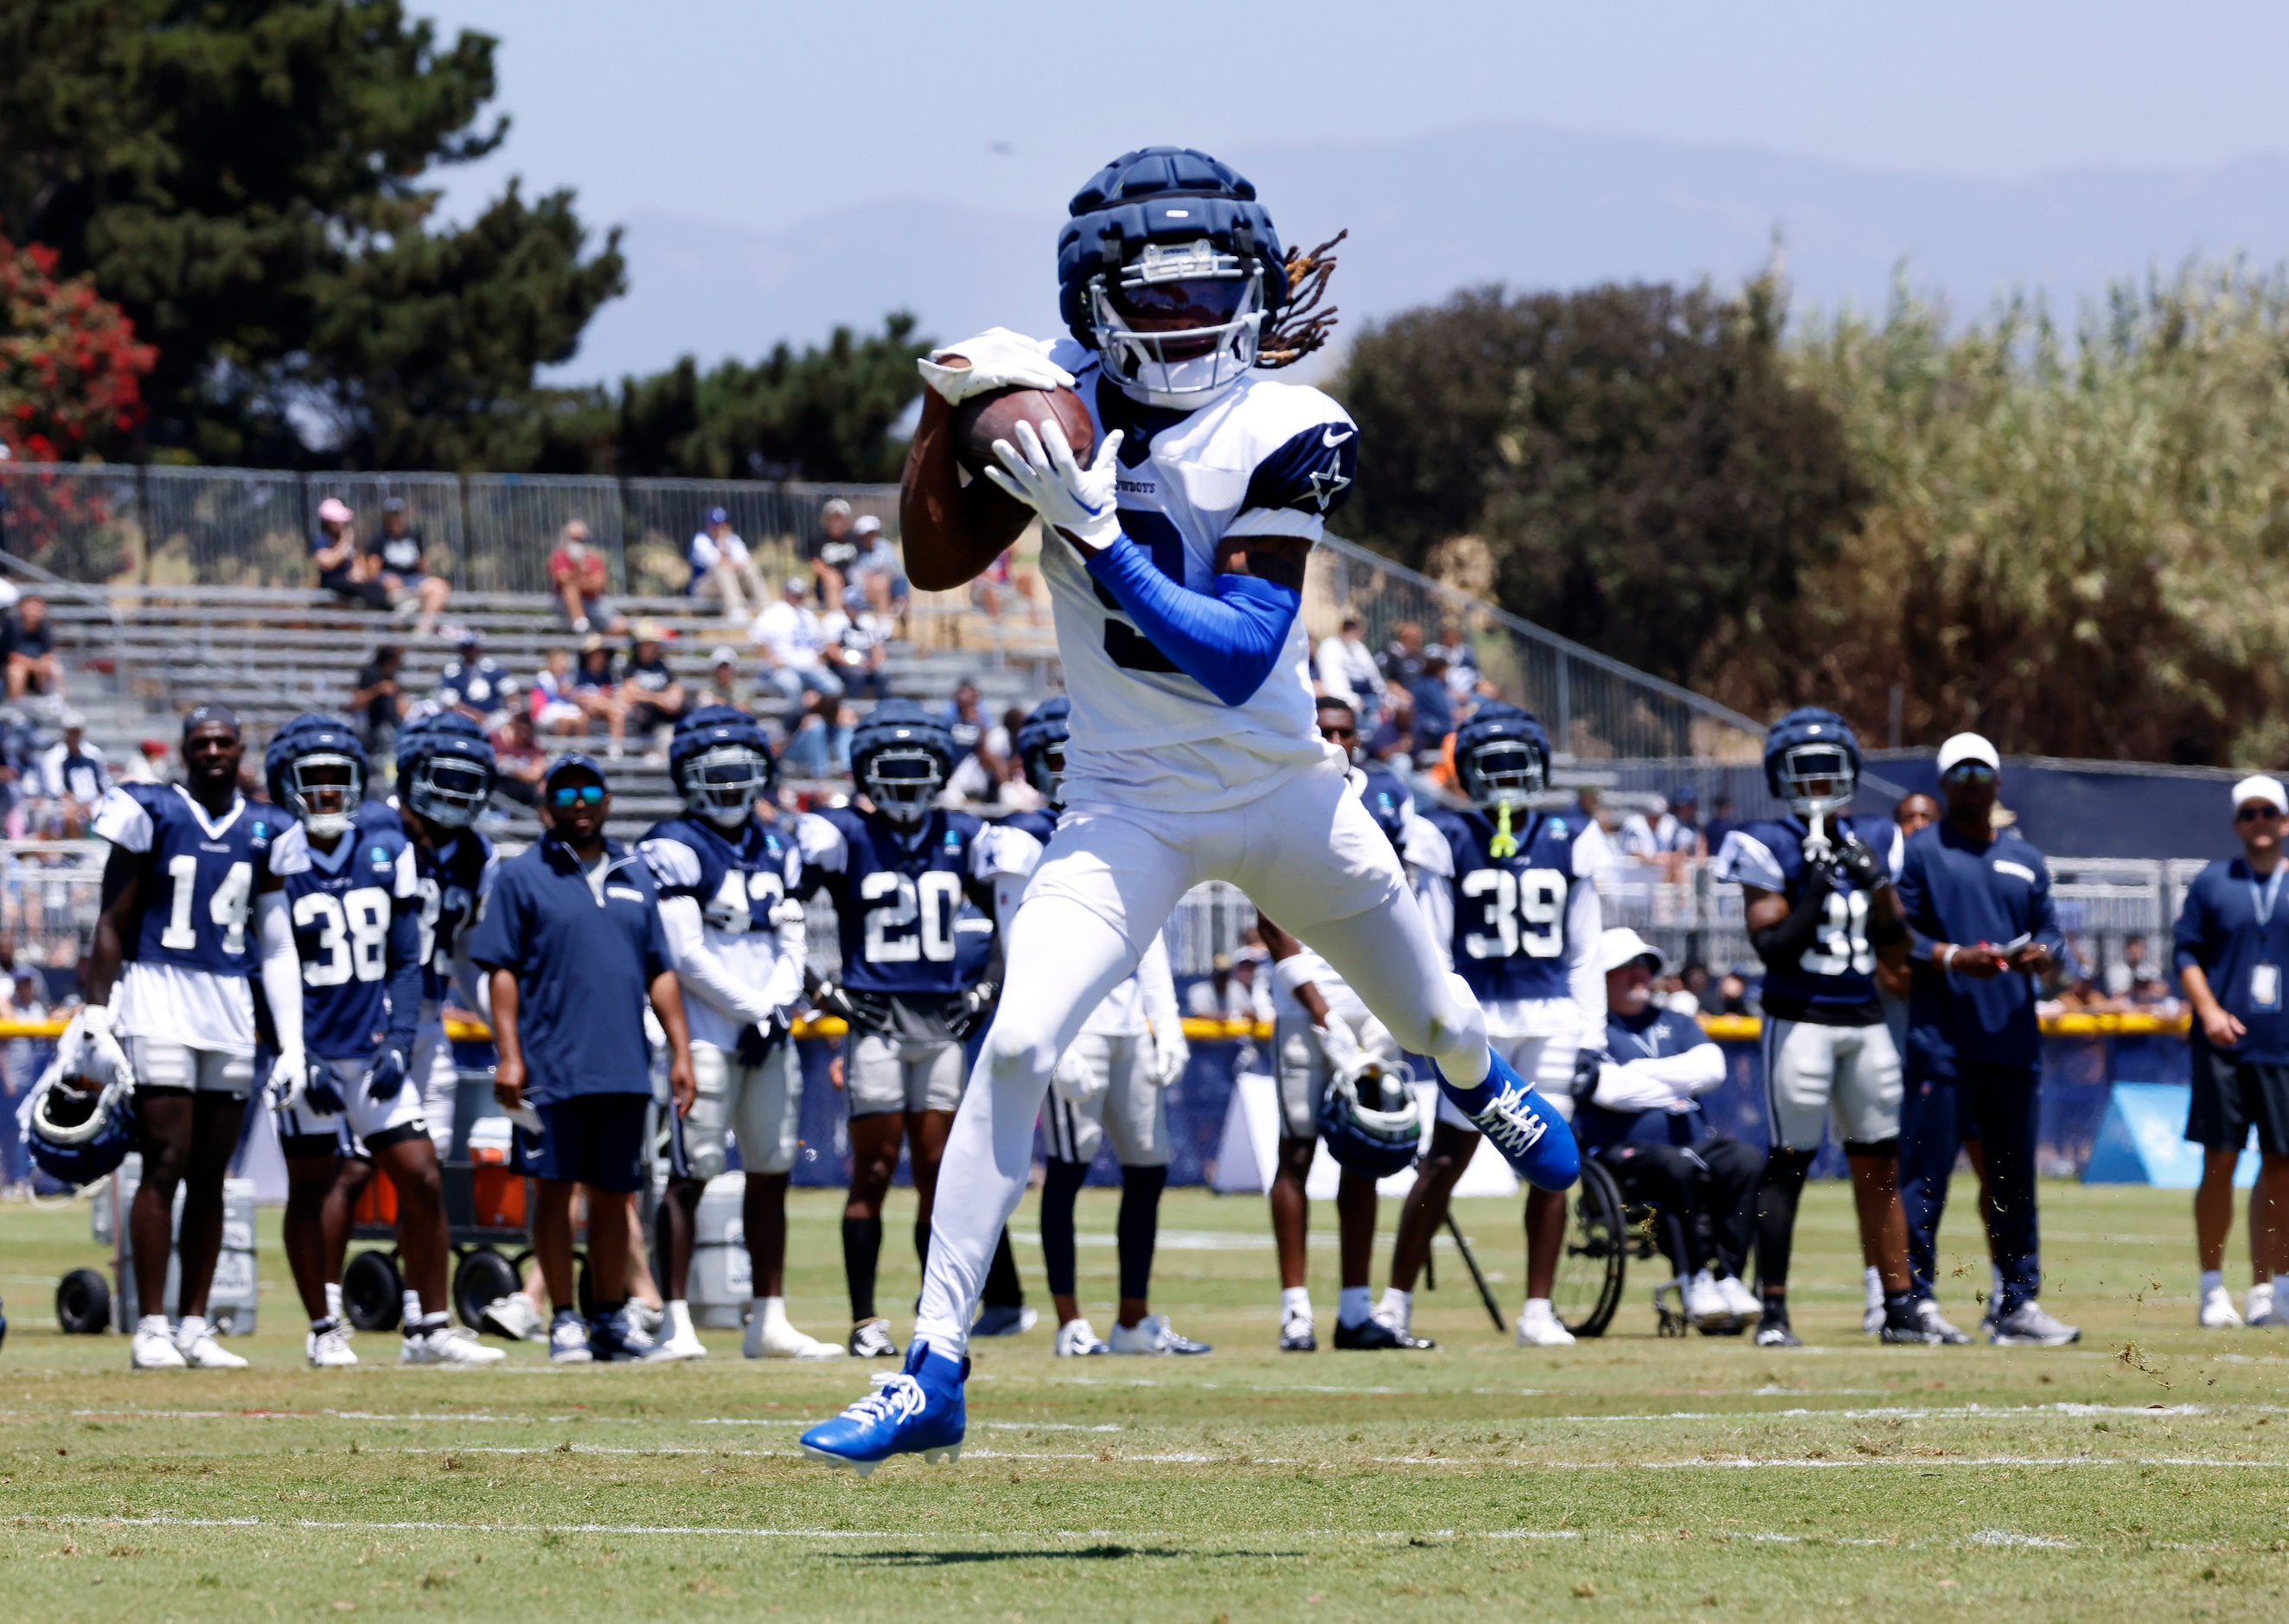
94, 783, 286, 975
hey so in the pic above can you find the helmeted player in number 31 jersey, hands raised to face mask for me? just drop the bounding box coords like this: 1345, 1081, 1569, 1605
1712, 707, 1941, 1346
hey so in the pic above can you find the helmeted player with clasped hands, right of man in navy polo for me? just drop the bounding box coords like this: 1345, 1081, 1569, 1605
641, 706, 842, 1359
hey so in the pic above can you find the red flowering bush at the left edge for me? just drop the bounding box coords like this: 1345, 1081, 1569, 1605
0, 238, 158, 463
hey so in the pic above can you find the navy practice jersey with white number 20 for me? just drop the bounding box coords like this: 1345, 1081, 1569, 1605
796, 806, 994, 996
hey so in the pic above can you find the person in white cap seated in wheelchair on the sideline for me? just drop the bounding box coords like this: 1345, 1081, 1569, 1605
1572, 930, 1765, 1335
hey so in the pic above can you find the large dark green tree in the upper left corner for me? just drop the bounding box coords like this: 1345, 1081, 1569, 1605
0, 0, 623, 463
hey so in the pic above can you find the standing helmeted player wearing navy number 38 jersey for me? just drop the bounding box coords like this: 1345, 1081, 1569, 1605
263, 714, 502, 1367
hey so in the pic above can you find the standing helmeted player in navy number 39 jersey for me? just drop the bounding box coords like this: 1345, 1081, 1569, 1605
1376, 703, 1605, 1346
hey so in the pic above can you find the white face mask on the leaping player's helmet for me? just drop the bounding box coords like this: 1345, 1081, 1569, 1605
1087, 238, 1266, 410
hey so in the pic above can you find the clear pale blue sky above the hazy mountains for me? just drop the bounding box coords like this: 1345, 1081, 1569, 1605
412, 0, 2289, 229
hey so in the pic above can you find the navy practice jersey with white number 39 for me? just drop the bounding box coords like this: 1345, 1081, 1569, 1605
1408, 806, 1593, 999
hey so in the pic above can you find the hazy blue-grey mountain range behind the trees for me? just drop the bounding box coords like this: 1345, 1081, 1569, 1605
559, 122, 2289, 380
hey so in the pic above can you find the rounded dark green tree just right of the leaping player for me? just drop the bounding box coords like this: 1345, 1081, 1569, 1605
1337, 279, 1864, 682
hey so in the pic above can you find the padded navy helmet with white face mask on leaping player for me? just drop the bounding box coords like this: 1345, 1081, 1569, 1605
1058, 147, 1288, 410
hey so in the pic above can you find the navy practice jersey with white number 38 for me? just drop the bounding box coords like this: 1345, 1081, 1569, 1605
272, 825, 419, 1060
